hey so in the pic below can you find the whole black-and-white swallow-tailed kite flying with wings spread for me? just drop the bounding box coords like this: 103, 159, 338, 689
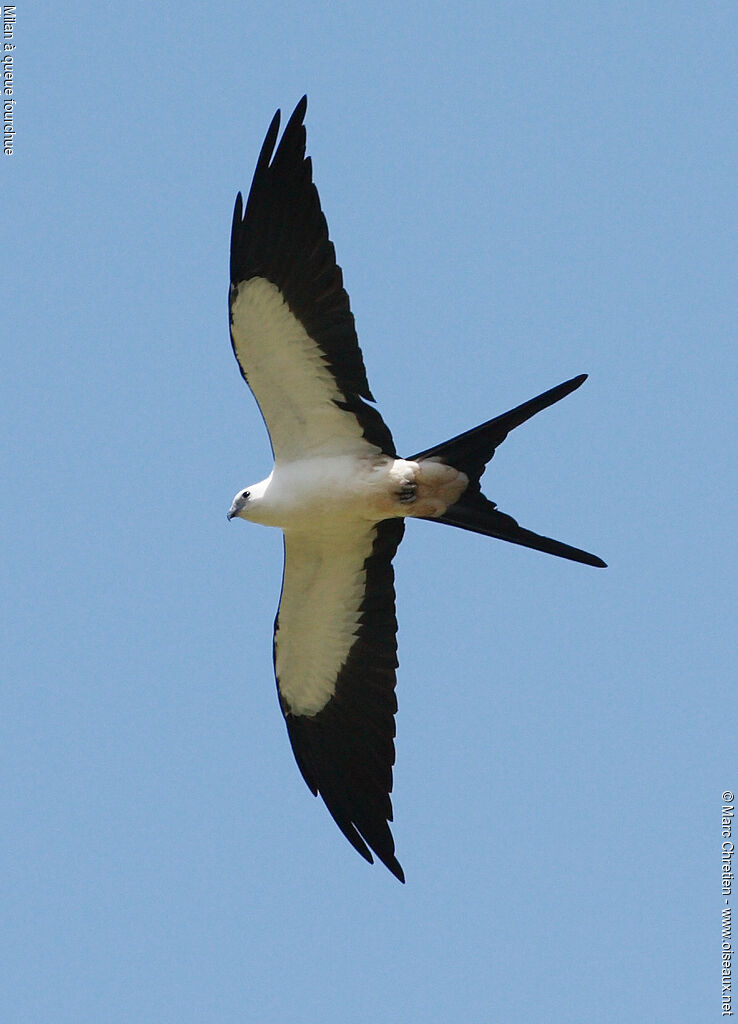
228, 96, 605, 882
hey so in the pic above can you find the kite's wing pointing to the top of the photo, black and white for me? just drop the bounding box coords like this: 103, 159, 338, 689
230, 96, 396, 461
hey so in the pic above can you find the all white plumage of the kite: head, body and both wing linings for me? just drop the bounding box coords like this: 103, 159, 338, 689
231, 278, 469, 715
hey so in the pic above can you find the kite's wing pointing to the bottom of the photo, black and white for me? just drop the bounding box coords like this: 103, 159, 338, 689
274, 519, 404, 882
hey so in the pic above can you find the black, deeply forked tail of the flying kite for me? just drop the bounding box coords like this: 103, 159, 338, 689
410, 374, 606, 568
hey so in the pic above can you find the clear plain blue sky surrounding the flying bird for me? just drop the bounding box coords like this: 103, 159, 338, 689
0, 0, 738, 1024
